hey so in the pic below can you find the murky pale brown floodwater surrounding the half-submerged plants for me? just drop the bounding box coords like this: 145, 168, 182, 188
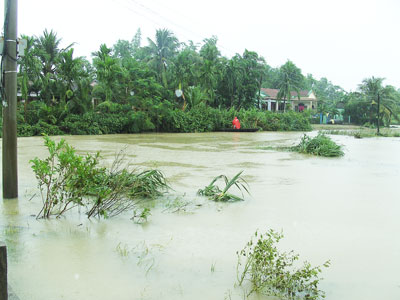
0, 132, 400, 300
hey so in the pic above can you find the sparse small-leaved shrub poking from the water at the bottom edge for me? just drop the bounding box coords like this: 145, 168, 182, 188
237, 230, 330, 300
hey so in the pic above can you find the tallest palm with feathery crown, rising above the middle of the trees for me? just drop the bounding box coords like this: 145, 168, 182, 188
147, 29, 179, 87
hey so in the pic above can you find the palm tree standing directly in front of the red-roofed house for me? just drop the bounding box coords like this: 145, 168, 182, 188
277, 60, 304, 112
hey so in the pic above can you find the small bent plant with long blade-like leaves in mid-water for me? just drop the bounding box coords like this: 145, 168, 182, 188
197, 171, 249, 202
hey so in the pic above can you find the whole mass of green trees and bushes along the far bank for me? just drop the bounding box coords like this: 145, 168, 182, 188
12, 29, 400, 136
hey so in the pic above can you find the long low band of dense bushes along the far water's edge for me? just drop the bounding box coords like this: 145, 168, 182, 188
13, 100, 311, 136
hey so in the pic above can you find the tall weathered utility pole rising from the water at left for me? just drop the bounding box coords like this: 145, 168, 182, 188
1, 0, 18, 199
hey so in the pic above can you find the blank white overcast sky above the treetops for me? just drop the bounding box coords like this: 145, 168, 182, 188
1, 0, 400, 91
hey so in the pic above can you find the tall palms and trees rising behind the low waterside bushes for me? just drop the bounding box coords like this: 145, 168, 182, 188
1, 29, 399, 136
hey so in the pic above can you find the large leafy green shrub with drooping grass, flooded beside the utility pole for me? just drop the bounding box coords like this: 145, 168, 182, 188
31, 136, 168, 218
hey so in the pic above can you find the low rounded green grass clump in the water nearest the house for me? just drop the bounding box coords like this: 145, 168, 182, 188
290, 133, 344, 157
